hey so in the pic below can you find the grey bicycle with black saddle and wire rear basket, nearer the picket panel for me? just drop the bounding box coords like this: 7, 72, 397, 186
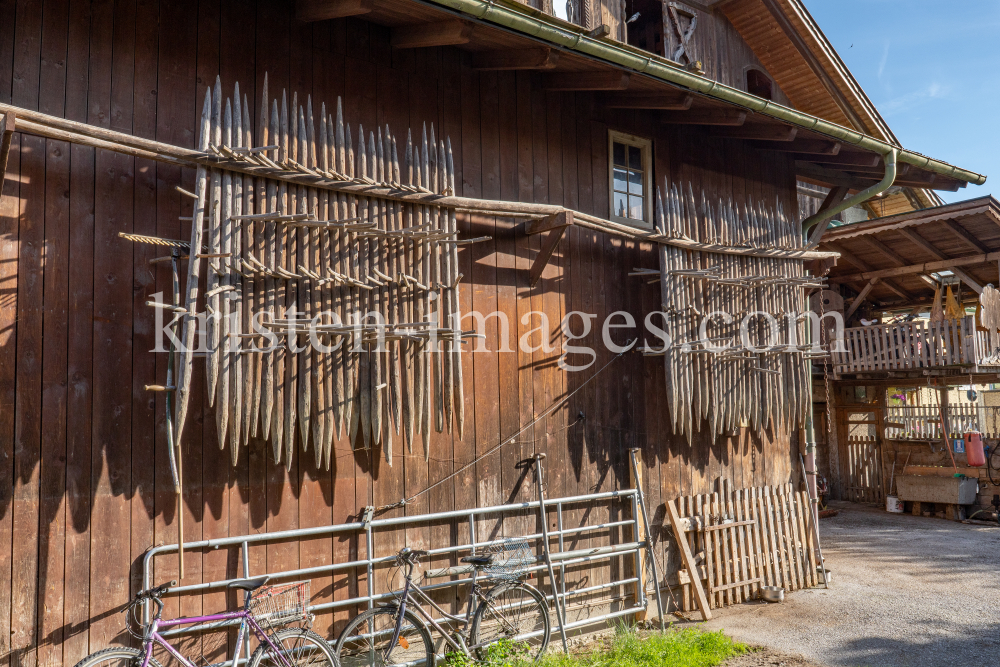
334, 540, 552, 667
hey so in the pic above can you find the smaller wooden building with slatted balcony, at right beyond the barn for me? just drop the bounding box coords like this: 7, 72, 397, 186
816, 196, 1000, 519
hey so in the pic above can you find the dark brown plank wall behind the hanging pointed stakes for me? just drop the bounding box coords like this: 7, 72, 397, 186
0, 0, 798, 664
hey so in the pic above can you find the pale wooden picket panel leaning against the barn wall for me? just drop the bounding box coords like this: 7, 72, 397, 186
670, 480, 822, 612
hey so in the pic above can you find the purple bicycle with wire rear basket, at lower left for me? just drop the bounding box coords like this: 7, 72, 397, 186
76, 577, 336, 667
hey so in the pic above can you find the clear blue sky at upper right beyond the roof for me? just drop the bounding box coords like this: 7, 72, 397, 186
805, 0, 1000, 202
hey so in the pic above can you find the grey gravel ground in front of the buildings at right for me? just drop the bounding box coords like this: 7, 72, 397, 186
703, 503, 1000, 667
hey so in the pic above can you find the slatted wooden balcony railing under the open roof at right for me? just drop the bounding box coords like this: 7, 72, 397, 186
833, 315, 1000, 377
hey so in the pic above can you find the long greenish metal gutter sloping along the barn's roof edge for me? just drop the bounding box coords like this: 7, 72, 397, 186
420, 0, 986, 185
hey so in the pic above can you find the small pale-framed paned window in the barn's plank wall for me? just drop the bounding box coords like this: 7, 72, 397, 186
609, 131, 653, 227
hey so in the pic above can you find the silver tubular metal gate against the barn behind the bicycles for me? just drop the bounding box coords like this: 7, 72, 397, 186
142, 489, 647, 656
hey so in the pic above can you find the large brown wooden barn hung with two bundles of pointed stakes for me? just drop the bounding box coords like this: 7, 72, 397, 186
0, 0, 995, 666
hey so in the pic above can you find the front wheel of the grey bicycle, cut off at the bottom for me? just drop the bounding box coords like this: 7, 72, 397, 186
334, 607, 434, 667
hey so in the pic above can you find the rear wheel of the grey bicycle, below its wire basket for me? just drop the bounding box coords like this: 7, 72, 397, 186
469, 583, 552, 660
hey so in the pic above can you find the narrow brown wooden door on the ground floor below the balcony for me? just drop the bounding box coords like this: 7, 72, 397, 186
838, 407, 885, 503
